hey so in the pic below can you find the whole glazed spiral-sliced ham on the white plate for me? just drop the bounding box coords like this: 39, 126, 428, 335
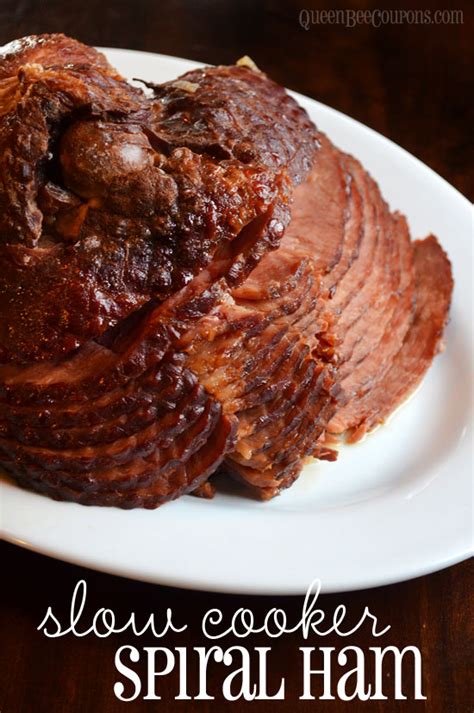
0, 35, 452, 508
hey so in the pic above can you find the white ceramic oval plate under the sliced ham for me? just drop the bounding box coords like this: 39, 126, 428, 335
1, 50, 474, 594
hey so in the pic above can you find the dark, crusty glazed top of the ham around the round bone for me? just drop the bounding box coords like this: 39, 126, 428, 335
0, 35, 317, 362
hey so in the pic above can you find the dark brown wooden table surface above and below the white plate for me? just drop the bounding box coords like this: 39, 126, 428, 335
0, 0, 474, 713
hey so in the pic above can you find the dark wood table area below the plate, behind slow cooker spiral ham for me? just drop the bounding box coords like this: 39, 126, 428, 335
0, 544, 474, 713
